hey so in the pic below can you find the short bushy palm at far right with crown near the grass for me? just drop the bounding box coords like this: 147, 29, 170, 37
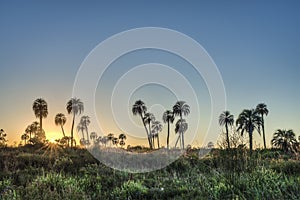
271, 129, 297, 152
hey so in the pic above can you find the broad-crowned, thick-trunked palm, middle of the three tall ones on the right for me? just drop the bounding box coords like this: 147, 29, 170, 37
236, 109, 261, 156
